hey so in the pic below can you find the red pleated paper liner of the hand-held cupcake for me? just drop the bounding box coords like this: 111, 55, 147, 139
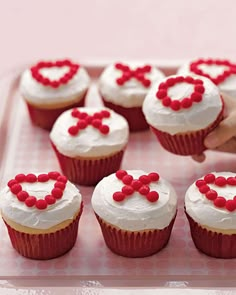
150, 110, 223, 156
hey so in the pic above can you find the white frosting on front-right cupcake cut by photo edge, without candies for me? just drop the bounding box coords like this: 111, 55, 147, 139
185, 172, 236, 230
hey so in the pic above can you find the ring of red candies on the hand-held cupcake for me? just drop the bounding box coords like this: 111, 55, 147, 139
156, 76, 205, 111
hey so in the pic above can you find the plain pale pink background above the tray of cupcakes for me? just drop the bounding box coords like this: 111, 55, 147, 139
0, 0, 236, 68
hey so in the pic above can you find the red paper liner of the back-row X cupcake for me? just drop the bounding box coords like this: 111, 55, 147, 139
102, 98, 149, 132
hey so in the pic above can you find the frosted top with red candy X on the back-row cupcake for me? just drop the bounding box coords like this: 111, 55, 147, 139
98, 62, 164, 108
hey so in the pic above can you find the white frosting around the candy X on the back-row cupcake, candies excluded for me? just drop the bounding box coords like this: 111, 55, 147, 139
98, 62, 164, 108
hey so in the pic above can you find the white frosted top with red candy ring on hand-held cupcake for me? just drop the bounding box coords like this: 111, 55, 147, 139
143, 75, 223, 135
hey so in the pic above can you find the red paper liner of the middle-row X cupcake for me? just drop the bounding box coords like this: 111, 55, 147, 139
51, 142, 124, 186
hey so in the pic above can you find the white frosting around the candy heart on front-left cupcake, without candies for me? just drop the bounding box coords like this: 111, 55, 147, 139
0, 176, 82, 229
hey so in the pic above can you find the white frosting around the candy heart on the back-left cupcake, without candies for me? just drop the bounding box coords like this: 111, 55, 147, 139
20, 66, 90, 105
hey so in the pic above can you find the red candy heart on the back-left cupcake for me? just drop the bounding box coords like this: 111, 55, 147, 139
30, 60, 79, 88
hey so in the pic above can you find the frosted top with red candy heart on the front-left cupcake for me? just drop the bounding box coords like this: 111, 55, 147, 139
0, 171, 82, 229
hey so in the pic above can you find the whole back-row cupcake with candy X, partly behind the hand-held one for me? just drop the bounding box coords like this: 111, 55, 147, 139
98, 62, 164, 131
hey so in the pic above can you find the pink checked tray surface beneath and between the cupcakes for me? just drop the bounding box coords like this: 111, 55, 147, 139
0, 68, 236, 285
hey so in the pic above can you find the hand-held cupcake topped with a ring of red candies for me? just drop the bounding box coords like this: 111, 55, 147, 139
143, 75, 223, 155
